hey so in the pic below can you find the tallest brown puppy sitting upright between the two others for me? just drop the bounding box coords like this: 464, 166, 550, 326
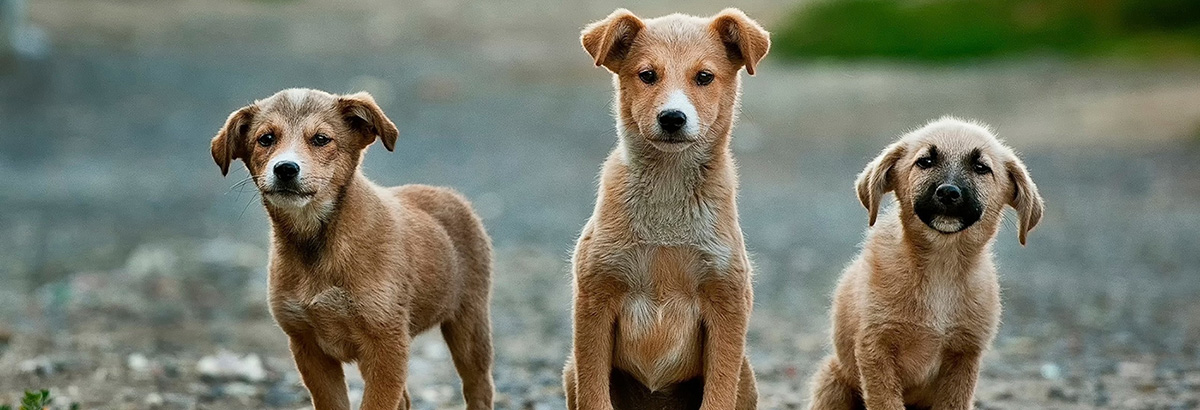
564, 8, 769, 409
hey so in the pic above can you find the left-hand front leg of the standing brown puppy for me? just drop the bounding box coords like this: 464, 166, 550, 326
288, 334, 350, 410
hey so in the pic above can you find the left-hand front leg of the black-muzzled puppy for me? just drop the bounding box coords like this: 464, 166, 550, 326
854, 325, 905, 410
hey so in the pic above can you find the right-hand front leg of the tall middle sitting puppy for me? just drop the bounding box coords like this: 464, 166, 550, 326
701, 278, 757, 410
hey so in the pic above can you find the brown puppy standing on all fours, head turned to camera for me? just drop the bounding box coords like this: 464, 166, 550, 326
212, 89, 493, 410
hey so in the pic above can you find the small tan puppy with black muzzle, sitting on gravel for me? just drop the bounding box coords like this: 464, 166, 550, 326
811, 117, 1043, 410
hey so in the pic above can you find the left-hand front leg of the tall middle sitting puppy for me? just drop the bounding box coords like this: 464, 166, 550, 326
568, 283, 616, 410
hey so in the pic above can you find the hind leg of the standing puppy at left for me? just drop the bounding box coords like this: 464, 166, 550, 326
442, 299, 494, 410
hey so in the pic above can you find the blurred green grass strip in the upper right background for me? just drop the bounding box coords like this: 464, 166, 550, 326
773, 0, 1200, 62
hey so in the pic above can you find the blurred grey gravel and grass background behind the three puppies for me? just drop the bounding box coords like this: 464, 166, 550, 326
0, 0, 1200, 409
